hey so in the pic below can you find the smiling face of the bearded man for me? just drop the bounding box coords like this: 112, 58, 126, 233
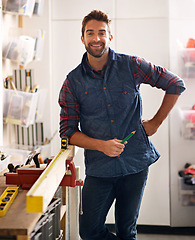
81, 20, 112, 58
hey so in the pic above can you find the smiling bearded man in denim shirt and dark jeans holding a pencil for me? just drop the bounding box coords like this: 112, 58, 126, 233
59, 10, 185, 240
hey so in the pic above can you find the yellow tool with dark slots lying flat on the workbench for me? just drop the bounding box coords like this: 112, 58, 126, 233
0, 187, 19, 217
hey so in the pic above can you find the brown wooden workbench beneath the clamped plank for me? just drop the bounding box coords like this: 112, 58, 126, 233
0, 171, 66, 240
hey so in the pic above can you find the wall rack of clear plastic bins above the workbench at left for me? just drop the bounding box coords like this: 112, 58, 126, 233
3, 3, 50, 169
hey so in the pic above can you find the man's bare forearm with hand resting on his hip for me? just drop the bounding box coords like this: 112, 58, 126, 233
143, 93, 180, 136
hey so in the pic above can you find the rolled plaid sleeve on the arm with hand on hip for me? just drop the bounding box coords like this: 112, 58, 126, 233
132, 57, 185, 94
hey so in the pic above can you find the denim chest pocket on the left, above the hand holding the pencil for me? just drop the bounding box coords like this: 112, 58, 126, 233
79, 87, 103, 115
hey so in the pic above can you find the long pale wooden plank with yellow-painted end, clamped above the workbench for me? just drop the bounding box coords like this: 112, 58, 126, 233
26, 145, 74, 212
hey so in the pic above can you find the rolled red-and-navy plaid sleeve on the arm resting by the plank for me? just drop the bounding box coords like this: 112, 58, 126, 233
58, 79, 79, 140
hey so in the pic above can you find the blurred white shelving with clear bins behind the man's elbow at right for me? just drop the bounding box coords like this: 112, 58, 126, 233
170, 41, 195, 227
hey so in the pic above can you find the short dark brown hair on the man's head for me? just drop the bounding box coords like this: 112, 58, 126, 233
81, 10, 111, 37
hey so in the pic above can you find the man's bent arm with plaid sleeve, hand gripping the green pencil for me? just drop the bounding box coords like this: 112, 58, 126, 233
59, 79, 126, 157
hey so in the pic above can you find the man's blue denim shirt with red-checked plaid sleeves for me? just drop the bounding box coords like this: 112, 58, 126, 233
59, 49, 185, 177
